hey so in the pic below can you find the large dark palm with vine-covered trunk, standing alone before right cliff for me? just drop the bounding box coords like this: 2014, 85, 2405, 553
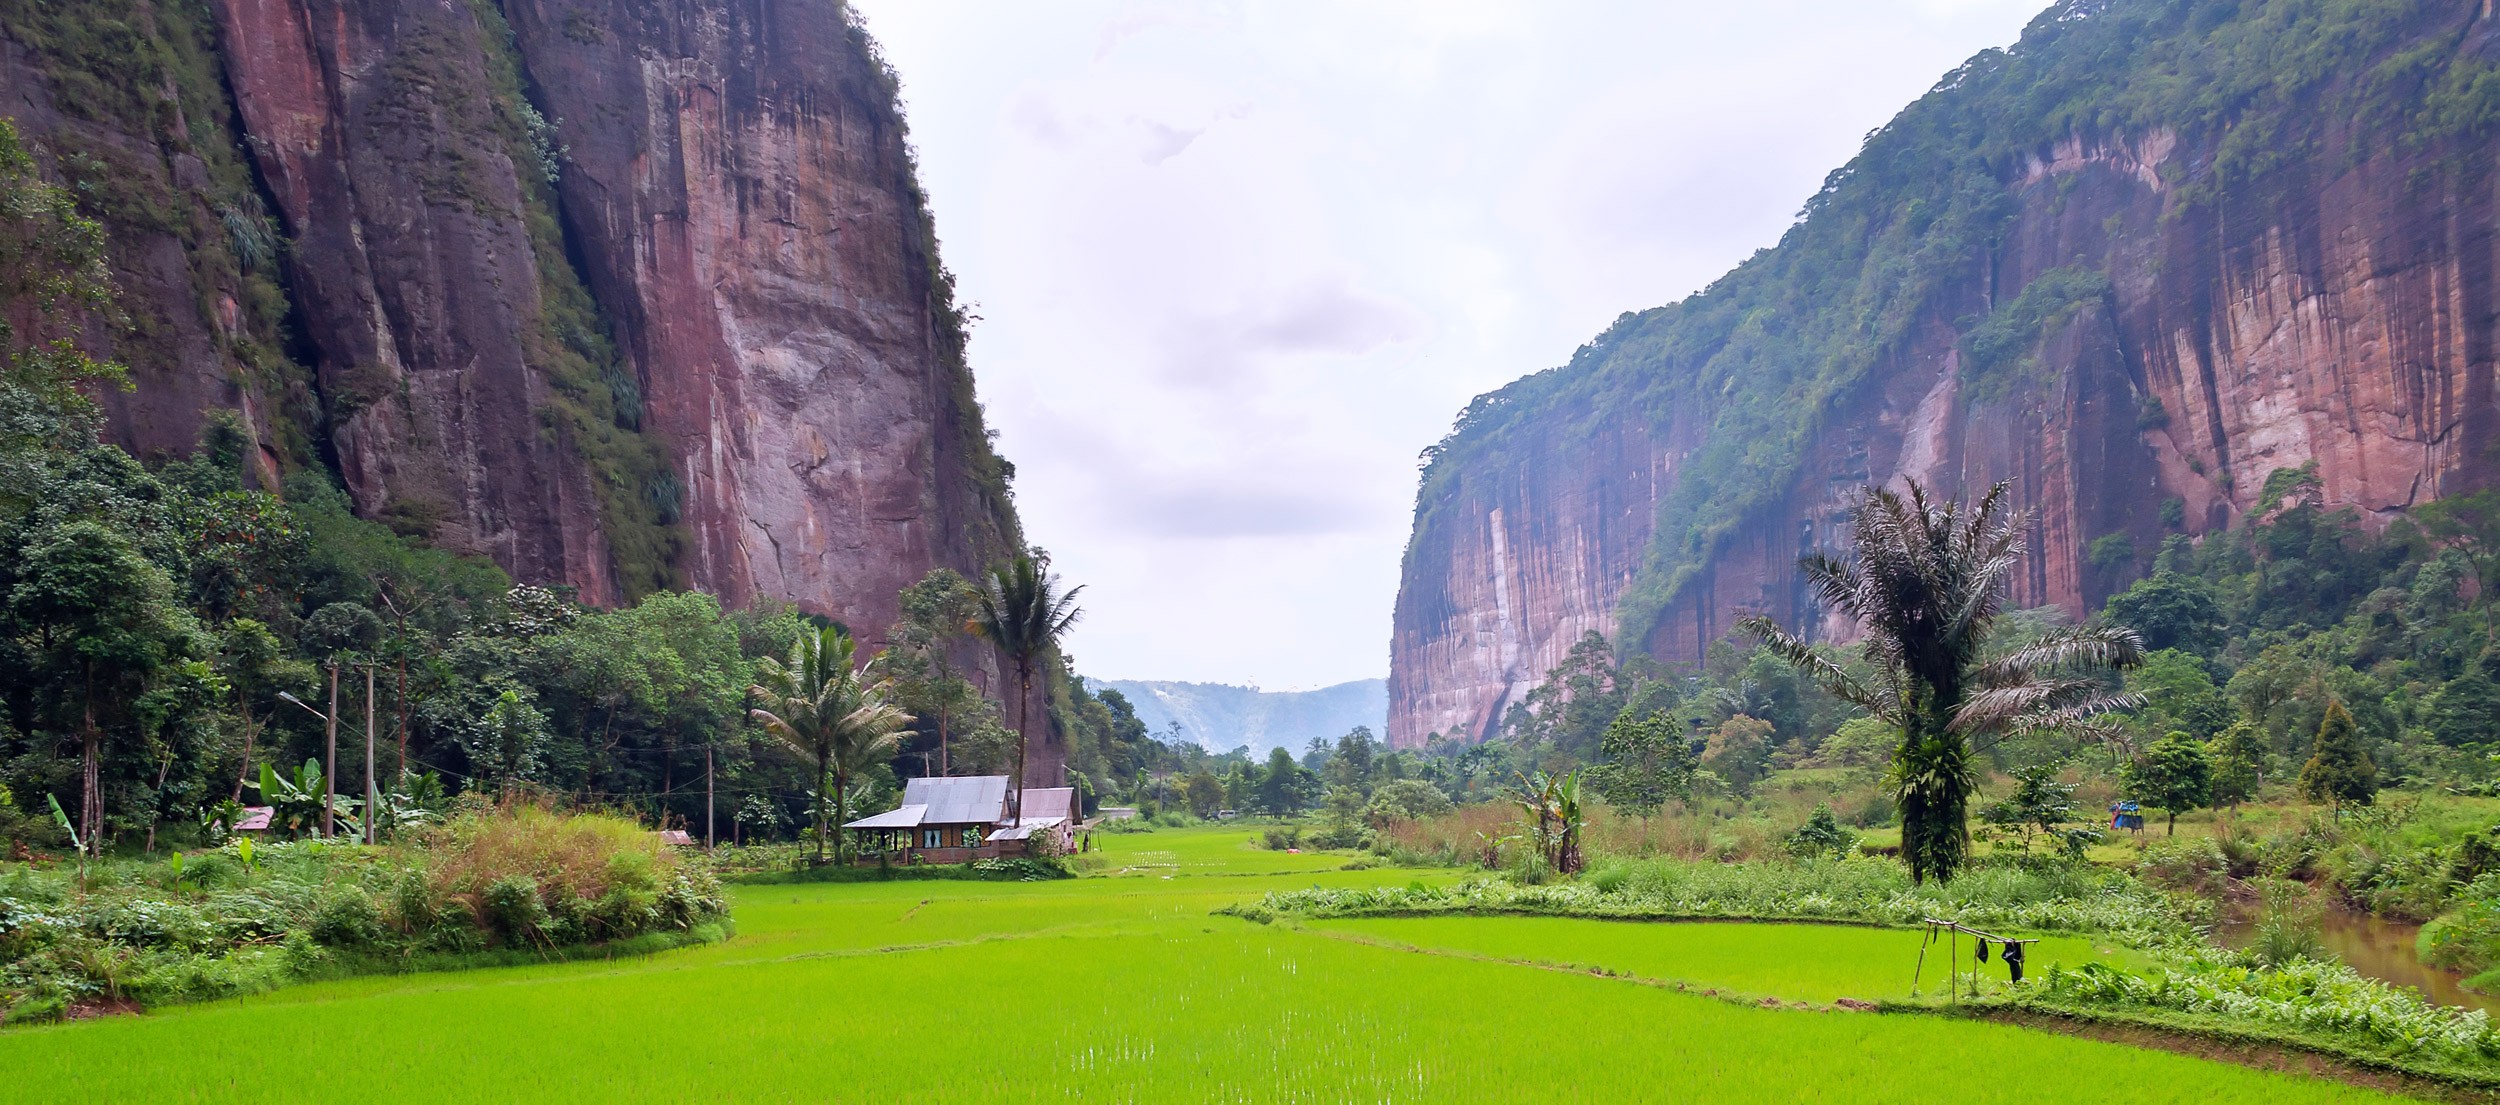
1740, 480, 2145, 883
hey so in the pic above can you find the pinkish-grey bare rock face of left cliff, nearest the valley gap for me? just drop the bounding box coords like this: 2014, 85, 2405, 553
510, 0, 1005, 630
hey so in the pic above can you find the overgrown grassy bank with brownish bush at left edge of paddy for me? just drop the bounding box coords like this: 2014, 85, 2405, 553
0, 808, 728, 1023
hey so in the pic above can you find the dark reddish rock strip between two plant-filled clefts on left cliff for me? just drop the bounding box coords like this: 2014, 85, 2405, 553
215, 0, 623, 603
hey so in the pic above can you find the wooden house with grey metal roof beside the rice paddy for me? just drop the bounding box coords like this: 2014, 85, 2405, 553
843, 775, 1078, 863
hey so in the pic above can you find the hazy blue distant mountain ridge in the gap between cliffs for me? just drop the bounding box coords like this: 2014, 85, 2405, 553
1095, 680, 1390, 755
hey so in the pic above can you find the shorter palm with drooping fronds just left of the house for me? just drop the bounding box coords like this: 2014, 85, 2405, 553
748, 625, 913, 863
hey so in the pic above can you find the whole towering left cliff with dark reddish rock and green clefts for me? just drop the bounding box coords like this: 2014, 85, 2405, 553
0, 0, 1020, 638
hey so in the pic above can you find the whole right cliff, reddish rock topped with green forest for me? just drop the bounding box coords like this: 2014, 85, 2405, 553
1390, 0, 2500, 745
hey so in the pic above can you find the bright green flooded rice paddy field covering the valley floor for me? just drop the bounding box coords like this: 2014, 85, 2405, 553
0, 830, 2420, 1105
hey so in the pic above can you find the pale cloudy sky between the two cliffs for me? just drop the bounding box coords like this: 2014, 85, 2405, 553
853, 0, 2045, 690
